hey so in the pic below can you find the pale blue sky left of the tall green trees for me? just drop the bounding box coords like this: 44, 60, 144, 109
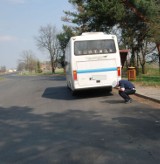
0, 0, 72, 69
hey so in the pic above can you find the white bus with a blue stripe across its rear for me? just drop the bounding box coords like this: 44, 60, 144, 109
65, 32, 121, 93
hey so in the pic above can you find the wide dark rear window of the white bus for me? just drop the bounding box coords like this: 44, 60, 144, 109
74, 39, 116, 55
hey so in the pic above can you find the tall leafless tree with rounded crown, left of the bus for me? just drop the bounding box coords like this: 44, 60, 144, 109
35, 24, 60, 73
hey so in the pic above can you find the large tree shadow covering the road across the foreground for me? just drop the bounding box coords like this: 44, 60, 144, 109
0, 106, 160, 164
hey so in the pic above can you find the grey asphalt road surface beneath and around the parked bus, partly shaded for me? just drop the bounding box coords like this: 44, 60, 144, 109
0, 74, 160, 164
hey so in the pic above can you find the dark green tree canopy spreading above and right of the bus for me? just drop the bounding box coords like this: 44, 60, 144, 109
64, 0, 160, 73
